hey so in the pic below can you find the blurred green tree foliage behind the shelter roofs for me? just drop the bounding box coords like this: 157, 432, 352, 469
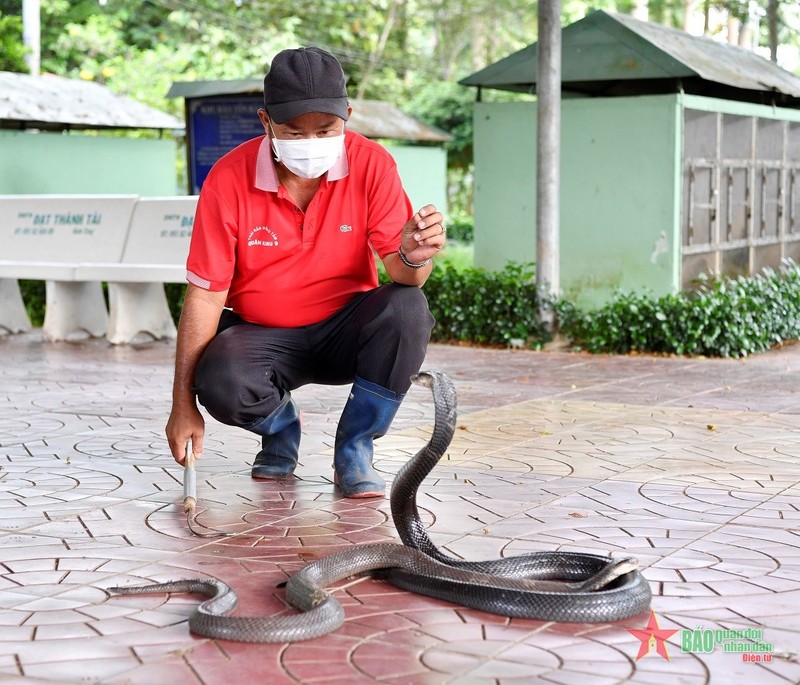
0, 0, 800, 210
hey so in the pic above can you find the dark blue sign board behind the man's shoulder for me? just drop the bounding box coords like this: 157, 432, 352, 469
186, 95, 264, 195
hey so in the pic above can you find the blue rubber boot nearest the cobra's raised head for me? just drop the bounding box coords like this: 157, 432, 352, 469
333, 376, 404, 497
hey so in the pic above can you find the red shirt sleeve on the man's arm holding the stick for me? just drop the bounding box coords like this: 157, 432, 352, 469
186, 183, 237, 291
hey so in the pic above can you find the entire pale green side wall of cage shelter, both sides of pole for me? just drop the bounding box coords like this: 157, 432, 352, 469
475, 95, 680, 306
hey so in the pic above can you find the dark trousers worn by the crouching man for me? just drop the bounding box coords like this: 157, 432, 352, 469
194, 284, 434, 427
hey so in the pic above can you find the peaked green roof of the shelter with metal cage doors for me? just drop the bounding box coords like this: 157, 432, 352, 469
459, 10, 800, 107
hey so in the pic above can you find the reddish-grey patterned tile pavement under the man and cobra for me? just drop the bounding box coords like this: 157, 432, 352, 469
0, 332, 800, 685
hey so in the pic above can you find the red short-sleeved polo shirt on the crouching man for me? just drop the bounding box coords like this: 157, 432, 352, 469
187, 131, 414, 328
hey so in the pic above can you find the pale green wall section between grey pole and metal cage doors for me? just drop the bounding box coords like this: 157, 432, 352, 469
561, 96, 681, 306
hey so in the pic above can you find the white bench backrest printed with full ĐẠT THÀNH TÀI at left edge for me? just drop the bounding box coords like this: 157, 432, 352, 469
0, 195, 138, 262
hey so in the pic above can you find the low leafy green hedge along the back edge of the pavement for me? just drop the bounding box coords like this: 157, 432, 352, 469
15, 262, 800, 357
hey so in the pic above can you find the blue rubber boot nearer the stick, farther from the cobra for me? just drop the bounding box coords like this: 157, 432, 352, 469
248, 392, 300, 478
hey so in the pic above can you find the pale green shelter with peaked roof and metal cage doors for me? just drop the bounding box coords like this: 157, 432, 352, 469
460, 11, 800, 306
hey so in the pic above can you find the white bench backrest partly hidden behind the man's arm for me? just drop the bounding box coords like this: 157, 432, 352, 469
122, 195, 197, 265
